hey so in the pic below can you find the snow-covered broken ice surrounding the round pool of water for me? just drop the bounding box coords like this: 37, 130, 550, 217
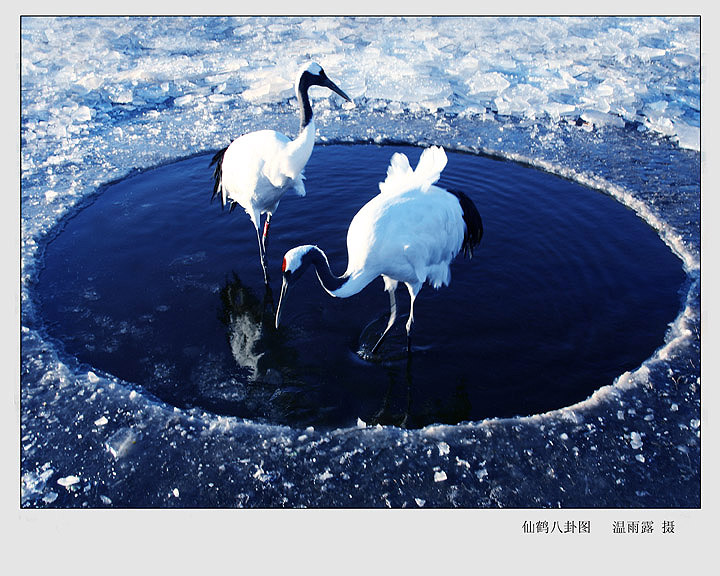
20, 17, 700, 508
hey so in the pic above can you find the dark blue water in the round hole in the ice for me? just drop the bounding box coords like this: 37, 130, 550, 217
37, 145, 684, 427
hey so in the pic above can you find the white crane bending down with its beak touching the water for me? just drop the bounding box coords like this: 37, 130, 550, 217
275, 146, 483, 354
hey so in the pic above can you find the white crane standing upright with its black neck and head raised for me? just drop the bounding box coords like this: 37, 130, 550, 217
210, 62, 350, 285
